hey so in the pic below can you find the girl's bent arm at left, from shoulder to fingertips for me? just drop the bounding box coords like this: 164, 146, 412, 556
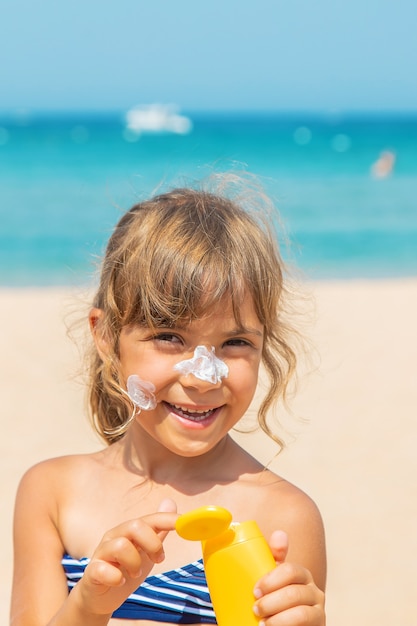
10, 461, 177, 626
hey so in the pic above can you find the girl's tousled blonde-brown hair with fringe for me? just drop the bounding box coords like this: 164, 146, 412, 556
89, 178, 296, 445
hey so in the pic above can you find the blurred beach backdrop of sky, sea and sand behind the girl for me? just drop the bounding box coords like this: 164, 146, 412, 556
0, 0, 417, 626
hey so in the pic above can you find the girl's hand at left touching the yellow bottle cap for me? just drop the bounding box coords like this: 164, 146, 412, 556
71, 500, 178, 616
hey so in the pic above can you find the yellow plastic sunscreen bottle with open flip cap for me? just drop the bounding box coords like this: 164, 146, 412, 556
176, 506, 276, 626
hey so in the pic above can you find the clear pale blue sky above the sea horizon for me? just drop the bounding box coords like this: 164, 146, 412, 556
0, 0, 417, 113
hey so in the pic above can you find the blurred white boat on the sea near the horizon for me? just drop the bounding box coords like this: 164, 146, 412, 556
126, 104, 193, 135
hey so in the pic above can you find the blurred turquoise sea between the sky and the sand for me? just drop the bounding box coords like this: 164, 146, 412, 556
0, 111, 417, 287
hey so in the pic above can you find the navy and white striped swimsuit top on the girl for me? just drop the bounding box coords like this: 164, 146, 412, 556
62, 554, 217, 624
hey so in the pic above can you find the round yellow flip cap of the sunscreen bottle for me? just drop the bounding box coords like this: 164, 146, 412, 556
175, 506, 232, 541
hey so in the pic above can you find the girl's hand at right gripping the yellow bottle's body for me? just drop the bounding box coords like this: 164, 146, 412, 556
250, 531, 326, 626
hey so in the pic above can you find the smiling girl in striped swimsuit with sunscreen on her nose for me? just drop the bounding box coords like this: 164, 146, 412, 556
11, 178, 326, 626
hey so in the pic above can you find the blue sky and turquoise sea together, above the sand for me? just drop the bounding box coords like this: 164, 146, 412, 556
0, 0, 417, 286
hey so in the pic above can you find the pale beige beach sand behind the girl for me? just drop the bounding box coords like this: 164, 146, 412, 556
0, 279, 417, 626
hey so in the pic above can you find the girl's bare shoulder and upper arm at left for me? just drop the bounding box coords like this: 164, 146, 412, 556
11, 455, 105, 624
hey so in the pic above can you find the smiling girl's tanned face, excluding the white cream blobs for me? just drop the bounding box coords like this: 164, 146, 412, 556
120, 296, 264, 456
